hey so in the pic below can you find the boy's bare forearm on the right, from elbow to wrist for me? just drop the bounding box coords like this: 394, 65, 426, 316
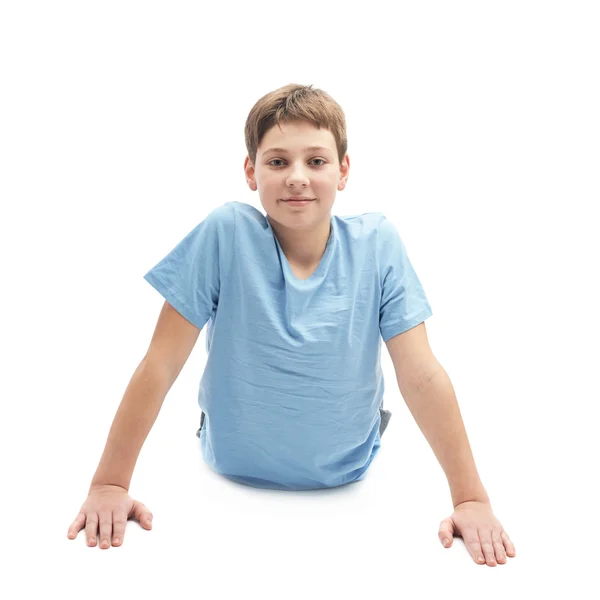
401, 365, 489, 506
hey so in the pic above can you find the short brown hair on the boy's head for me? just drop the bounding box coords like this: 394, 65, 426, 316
244, 83, 348, 165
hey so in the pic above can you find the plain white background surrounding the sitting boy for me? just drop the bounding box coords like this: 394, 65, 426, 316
0, 0, 600, 600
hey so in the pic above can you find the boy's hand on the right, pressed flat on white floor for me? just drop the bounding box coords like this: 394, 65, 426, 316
438, 501, 516, 567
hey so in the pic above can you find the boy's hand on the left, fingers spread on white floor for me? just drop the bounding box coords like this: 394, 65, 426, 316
67, 485, 152, 548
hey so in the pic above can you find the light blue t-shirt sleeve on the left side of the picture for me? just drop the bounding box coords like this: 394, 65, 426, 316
144, 203, 235, 329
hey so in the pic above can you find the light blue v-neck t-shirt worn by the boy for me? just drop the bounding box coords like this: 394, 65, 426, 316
144, 202, 432, 490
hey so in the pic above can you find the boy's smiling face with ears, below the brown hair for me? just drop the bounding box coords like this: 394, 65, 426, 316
244, 121, 350, 229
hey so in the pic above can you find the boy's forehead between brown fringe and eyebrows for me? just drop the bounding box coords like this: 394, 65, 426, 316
259, 121, 335, 154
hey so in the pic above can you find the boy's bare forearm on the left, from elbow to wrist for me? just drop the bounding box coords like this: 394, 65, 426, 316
90, 360, 172, 490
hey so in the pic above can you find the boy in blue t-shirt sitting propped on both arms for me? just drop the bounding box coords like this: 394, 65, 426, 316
69, 85, 514, 565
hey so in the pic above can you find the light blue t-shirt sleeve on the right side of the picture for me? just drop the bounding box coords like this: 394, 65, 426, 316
377, 215, 433, 342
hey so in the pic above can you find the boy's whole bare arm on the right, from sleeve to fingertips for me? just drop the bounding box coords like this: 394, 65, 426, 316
386, 322, 515, 566
